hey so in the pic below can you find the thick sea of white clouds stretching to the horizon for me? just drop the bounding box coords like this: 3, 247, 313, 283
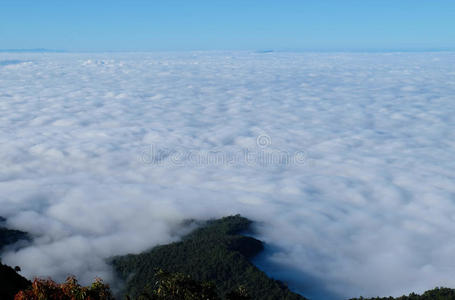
0, 52, 455, 299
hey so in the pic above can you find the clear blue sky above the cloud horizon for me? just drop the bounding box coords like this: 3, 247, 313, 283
0, 0, 455, 51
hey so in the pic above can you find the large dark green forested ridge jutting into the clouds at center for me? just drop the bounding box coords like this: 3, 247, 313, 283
112, 215, 305, 300
